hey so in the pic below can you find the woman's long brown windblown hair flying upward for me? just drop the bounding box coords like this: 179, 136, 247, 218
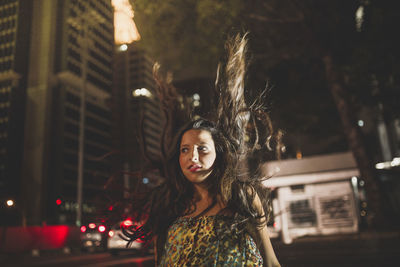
124, 35, 282, 258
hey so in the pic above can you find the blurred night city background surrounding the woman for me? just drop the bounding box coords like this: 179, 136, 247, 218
0, 0, 400, 266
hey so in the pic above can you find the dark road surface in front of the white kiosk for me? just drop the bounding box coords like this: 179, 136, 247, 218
274, 232, 400, 267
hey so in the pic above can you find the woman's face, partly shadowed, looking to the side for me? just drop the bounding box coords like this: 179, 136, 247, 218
179, 129, 216, 184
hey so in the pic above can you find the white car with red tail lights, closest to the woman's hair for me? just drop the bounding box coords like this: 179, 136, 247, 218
107, 219, 153, 255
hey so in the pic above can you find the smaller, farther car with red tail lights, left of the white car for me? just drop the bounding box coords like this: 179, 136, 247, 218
80, 222, 107, 252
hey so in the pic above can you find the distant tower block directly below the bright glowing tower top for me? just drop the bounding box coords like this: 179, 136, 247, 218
114, 44, 165, 191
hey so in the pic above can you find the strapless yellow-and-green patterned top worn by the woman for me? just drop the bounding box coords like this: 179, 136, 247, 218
159, 215, 263, 267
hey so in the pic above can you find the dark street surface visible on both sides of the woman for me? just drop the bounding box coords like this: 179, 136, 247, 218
0, 232, 400, 267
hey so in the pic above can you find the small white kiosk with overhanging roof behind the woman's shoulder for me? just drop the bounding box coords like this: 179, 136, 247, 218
263, 152, 360, 244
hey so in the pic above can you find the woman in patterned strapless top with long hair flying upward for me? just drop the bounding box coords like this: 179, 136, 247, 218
126, 33, 280, 266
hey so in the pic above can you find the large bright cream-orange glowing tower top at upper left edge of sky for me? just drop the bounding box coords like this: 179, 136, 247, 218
111, 0, 140, 44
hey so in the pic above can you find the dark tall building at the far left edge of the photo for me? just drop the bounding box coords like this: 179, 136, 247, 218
0, 0, 32, 224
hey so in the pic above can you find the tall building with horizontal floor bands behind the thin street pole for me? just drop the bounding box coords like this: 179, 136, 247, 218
46, 0, 114, 227
